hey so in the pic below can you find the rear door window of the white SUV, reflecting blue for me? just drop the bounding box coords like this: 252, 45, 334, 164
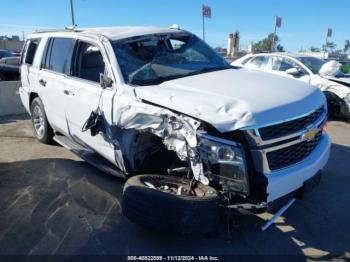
42, 38, 76, 75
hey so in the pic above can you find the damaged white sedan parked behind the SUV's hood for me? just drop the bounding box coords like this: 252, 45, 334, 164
232, 53, 350, 120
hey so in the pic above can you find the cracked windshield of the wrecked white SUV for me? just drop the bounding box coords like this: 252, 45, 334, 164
112, 34, 231, 85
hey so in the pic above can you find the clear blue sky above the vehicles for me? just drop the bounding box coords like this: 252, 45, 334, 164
0, 0, 350, 52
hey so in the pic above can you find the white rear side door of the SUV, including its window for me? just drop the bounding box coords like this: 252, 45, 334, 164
37, 37, 76, 134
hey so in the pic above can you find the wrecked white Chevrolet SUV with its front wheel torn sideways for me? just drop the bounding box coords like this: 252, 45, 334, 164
20, 27, 330, 233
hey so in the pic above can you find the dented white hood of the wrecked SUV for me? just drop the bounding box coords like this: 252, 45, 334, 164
135, 69, 325, 132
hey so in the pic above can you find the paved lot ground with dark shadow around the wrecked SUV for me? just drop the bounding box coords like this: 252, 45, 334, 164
0, 116, 350, 260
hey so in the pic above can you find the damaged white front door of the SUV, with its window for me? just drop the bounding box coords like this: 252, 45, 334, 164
65, 40, 115, 163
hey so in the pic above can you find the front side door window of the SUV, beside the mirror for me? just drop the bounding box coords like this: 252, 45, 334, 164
73, 42, 105, 83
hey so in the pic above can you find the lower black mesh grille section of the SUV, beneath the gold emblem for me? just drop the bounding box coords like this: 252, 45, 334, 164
266, 131, 322, 171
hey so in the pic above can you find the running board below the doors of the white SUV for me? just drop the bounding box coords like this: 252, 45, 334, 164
53, 135, 126, 178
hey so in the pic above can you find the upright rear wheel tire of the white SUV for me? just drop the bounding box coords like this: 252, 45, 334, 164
30, 97, 53, 144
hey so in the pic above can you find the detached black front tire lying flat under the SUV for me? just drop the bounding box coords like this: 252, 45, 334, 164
122, 175, 219, 234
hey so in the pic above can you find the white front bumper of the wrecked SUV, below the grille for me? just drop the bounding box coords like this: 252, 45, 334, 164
267, 134, 331, 204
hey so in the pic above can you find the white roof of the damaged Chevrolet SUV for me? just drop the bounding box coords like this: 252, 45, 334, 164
35, 26, 184, 40
